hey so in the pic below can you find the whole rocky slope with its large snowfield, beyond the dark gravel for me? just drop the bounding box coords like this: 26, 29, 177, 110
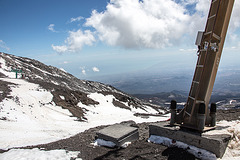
0, 53, 169, 149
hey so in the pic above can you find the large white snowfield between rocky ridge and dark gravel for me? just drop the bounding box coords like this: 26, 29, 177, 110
0, 78, 170, 149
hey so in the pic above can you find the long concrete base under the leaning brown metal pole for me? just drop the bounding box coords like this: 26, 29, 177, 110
149, 122, 231, 158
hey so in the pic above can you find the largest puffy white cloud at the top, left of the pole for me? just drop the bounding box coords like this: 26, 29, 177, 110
86, 0, 190, 48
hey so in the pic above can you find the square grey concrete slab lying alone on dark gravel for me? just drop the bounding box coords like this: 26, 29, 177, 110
97, 124, 139, 146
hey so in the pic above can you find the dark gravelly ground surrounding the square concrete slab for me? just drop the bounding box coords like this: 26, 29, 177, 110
10, 109, 240, 160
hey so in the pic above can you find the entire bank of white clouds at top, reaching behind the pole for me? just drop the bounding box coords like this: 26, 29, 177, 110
53, 0, 240, 52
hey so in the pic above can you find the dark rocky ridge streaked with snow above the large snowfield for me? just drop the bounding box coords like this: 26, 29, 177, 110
0, 53, 166, 120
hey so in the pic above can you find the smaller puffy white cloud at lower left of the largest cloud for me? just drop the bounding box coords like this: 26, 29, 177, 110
52, 29, 96, 53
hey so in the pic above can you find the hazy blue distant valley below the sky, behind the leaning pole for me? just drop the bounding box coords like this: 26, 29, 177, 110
94, 69, 240, 108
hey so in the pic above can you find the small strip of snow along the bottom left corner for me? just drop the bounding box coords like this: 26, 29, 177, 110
0, 148, 81, 160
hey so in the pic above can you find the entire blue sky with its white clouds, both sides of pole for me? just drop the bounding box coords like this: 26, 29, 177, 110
0, 0, 240, 80
